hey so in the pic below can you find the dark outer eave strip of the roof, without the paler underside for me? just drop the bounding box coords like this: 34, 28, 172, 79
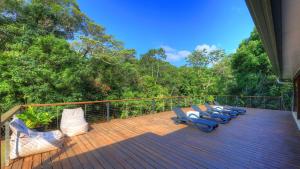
246, 0, 288, 80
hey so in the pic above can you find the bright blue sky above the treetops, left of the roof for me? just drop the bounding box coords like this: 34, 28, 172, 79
78, 0, 254, 66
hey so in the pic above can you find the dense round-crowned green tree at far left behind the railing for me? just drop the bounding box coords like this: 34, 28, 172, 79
0, 35, 92, 111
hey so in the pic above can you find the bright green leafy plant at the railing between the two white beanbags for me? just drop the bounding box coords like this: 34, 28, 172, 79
17, 106, 55, 129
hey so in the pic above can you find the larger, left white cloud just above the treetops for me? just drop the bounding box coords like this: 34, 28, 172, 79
161, 46, 191, 62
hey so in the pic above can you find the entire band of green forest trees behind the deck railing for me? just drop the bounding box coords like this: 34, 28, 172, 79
0, 0, 291, 118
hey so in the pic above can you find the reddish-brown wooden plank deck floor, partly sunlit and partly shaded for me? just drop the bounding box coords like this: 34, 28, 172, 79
3, 109, 300, 169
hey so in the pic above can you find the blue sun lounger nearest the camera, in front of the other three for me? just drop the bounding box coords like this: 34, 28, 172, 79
173, 107, 218, 132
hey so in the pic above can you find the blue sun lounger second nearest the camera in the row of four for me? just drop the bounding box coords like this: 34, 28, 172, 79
192, 105, 231, 124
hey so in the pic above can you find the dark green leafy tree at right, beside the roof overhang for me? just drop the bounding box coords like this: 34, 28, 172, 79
229, 30, 291, 96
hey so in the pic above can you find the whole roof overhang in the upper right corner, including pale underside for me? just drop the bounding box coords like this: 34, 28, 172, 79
246, 0, 300, 80
